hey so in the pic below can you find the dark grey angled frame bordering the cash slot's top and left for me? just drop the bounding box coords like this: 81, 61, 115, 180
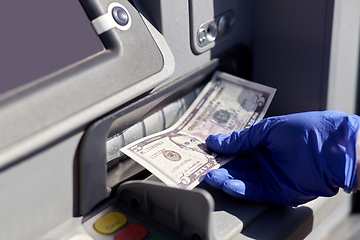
74, 60, 218, 216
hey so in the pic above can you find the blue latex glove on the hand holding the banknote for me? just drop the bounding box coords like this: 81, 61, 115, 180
205, 111, 360, 206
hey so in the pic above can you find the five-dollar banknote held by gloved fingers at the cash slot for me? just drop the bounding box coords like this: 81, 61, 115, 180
121, 71, 276, 189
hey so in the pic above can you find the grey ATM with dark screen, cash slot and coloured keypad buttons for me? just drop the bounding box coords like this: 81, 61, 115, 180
0, 0, 360, 240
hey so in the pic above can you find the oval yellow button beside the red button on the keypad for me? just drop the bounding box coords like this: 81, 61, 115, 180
94, 212, 127, 234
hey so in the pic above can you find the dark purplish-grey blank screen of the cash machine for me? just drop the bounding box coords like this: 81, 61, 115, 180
0, 0, 104, 95
